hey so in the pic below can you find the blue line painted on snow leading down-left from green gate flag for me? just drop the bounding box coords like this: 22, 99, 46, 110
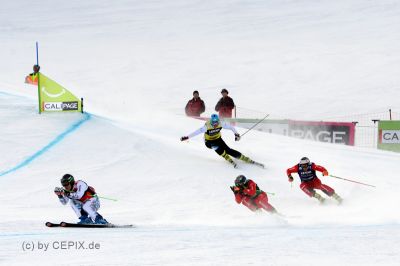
0, 113, 91, 176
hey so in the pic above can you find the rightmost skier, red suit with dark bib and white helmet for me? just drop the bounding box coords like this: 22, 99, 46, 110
286, 157, 342, 203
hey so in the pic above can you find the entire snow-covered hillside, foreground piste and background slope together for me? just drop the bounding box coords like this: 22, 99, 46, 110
0, 0, 400, 265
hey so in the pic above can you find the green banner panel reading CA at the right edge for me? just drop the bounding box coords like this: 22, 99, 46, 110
378, 120, 400, 152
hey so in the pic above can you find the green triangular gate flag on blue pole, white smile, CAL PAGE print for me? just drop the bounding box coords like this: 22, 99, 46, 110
38, 73, 82, 113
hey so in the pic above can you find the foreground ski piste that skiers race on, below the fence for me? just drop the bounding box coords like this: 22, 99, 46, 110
0, 91, 400, 265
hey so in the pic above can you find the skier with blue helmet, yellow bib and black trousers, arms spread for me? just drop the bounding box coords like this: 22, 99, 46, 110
181, 114, 264, 168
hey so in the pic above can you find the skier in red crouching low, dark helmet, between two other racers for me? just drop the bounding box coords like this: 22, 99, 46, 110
231, 175, 276, 213
